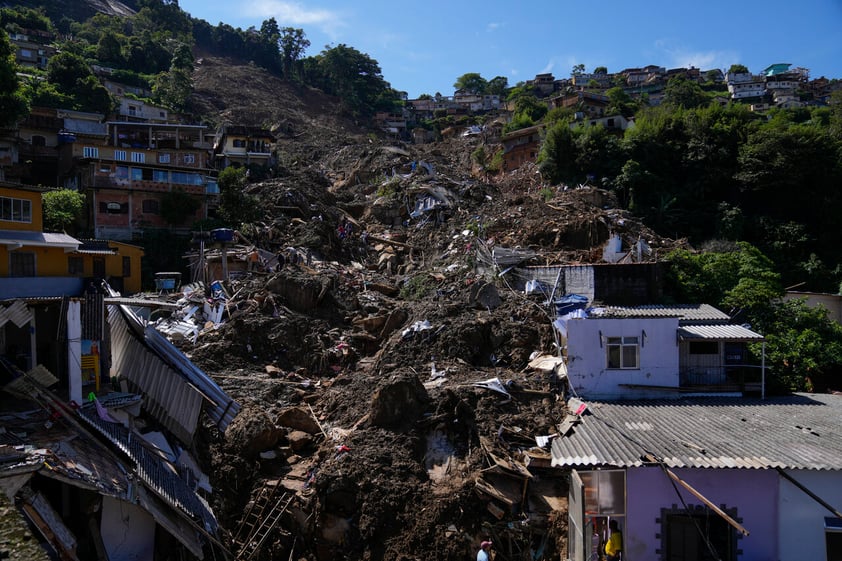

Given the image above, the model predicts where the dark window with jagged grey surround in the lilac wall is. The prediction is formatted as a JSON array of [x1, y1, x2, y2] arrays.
[[661, 506, 736, 561]]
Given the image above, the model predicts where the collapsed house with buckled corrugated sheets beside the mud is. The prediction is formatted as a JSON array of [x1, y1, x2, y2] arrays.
[[0, 287, 239, 561]]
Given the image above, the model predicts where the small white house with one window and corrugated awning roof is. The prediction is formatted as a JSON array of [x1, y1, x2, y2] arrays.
[[557, 304, 763, 400]]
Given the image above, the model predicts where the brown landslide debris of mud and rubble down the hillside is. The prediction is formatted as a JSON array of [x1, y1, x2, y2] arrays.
[[171, 57, 678, 560]]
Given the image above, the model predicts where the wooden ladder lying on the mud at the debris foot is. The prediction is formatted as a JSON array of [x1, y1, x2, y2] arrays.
[[234, 481, 295, 561]]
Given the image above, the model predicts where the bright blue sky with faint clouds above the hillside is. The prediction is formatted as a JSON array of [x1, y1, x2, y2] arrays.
[[179, 0, 842, 98]]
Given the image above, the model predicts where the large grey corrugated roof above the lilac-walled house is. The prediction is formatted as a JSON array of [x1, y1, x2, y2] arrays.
[[552, 394, 842, 470]]
